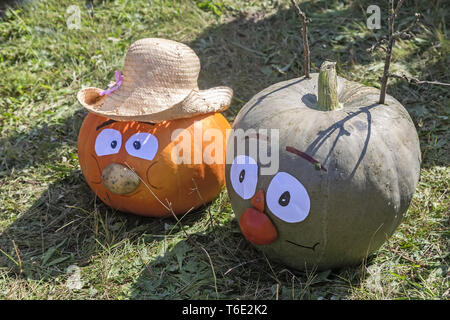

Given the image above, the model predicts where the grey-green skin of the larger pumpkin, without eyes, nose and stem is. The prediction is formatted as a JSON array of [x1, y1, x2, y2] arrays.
[[226, 73, 421, 270]]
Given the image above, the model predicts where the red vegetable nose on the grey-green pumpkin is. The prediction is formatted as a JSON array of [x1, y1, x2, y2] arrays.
[[239, 190, 278, 245]]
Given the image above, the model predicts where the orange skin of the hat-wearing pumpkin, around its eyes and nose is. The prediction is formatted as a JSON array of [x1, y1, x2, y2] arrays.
[[78, 113, 230, 217]]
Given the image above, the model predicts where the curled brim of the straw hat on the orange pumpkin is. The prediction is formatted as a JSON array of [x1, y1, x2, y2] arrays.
[[77, 86, 233, 122]]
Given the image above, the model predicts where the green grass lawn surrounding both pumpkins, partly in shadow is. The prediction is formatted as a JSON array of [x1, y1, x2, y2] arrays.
[[0, 0, 450, 299]]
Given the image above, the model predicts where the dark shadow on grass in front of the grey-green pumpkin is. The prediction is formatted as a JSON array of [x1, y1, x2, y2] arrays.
[[130, 221, 370, 300]]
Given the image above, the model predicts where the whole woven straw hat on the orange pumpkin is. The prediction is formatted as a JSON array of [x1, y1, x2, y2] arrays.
[[77, 38, 233, 122]]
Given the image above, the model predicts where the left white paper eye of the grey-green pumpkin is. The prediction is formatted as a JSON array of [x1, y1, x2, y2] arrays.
[[230, 155, 258, 200]]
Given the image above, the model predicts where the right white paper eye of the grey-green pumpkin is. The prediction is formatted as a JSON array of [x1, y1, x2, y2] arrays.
[[266, 172, 311, 223]]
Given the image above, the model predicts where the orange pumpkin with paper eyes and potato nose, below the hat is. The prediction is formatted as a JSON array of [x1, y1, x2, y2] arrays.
[[78, 113, 230, 217]]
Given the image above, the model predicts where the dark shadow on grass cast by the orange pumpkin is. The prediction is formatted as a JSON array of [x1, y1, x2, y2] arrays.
[[0, 170, 204, 282]]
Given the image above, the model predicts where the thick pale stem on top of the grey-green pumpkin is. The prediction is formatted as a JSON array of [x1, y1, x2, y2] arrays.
[[317, 61, 342, 111]]
